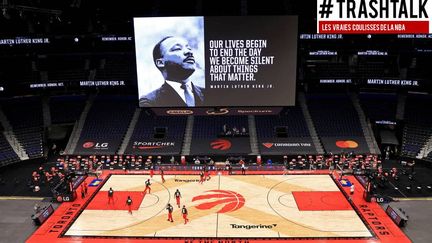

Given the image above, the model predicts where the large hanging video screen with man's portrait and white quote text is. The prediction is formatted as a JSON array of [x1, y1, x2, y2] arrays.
[[134, 16, 298, 107]]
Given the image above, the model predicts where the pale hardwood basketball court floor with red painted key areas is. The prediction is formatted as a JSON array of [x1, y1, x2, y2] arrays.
[[64, 174, 373, 239]]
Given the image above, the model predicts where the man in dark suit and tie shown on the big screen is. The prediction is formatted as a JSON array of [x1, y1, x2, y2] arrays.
[[139, 36, 204, 107]]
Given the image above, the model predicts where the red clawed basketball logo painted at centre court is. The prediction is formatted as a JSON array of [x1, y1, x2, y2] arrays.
[[192, 190, 245, 213]]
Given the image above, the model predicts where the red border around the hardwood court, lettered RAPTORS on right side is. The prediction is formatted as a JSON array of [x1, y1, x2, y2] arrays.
[[26, 170, 411, 243]]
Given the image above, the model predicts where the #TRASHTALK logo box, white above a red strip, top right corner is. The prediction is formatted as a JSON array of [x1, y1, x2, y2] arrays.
[[317, 0, 432, 34]]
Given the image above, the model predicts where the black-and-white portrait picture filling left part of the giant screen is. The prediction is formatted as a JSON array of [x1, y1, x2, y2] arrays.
[[134, 17, 205, 107]]
